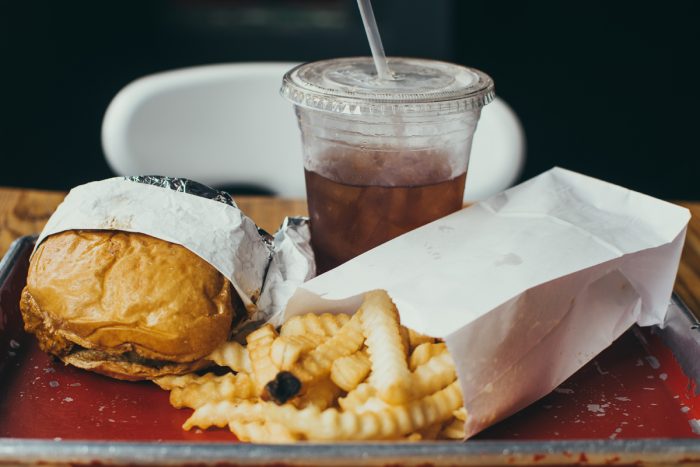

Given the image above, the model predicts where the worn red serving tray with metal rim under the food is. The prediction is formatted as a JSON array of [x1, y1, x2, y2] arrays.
[[0, 238, 700, 464]]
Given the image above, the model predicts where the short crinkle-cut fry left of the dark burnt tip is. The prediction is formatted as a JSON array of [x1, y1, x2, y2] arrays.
[[170, 373, 256, 409]]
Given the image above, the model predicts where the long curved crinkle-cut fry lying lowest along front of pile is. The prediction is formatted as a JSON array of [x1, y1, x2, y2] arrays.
[[211, 382, 462, 441]]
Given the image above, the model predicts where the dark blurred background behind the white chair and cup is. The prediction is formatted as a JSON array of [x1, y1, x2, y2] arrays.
[[0, 0, 700, 199]]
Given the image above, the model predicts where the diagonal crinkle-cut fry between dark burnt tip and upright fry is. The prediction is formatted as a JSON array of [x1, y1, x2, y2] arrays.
[[290, 308, 364, 393]]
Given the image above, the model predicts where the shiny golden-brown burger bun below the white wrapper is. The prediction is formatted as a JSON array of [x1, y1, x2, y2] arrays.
[[20, 231, 234, 379]]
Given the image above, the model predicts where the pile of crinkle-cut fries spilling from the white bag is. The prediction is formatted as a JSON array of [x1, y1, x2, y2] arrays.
[[155, 291, 467, 443]]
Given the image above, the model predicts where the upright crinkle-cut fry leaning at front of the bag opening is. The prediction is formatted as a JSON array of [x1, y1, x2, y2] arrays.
[[357, 290, 411, 404]]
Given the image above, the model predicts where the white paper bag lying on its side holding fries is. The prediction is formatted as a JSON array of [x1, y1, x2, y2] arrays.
[[275, 168, 690, 436]]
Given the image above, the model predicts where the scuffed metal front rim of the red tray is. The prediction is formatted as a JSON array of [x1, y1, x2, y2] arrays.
[[0, 438, 700, 465]]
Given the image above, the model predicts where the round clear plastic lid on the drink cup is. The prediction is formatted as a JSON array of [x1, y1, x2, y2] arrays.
[[280, 57, 494, 115]]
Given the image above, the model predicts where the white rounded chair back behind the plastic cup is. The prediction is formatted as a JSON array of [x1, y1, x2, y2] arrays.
[[102, 63, 525, 201]]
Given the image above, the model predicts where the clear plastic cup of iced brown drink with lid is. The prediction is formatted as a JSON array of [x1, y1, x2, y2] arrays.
[[281, 57, 494, 272]]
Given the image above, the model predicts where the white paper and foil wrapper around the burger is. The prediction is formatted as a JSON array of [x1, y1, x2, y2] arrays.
[[36, 176, 315, 330]]
